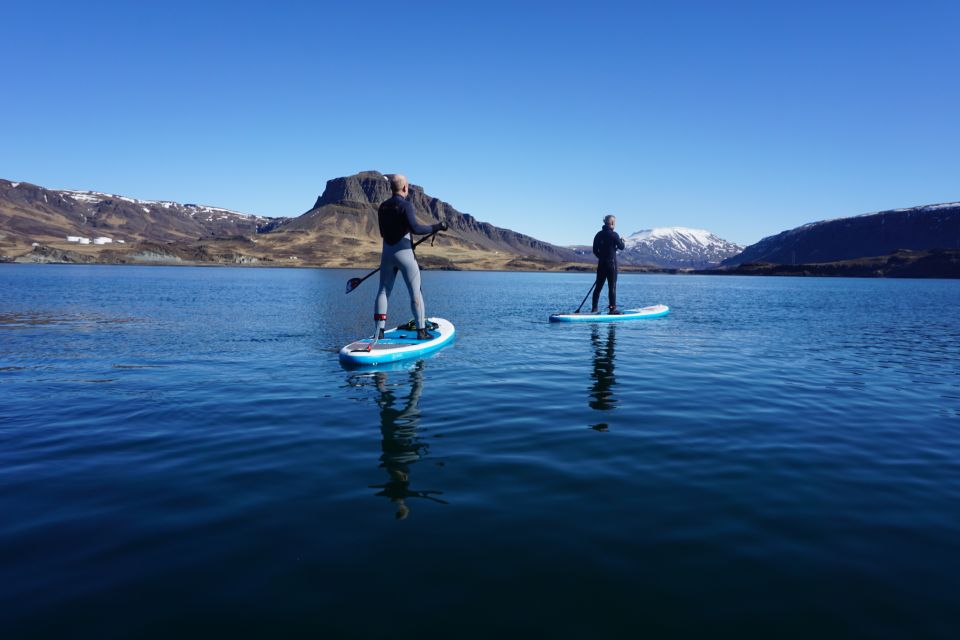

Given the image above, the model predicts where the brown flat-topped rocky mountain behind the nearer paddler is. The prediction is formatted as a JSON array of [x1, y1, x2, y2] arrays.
[[263, 171, 582, 269]]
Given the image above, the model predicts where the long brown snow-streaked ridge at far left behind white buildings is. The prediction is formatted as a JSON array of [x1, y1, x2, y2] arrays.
[[0, 180, 283, 248]]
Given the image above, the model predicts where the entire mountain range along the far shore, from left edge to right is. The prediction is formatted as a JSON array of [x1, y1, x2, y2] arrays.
[[0, 171, 960, 277]]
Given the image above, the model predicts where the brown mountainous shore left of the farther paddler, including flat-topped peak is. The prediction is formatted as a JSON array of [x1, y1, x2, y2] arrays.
[[0, 171, 586, 270]]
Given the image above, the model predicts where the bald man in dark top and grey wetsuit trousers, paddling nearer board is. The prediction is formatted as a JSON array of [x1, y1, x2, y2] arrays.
[[373, 174, 447, 340]]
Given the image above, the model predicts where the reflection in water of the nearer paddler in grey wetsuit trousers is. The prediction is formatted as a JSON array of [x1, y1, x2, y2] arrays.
[[371, 362, 447, 520]]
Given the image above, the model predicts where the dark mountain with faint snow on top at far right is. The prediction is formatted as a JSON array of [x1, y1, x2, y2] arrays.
[[723, 202, 960, 266]]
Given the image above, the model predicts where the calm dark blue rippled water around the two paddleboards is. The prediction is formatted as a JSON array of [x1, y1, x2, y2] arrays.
[[0, 265, 960, 638]]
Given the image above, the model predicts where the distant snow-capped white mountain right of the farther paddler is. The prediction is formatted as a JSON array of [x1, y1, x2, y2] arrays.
[[620, 227, 743, 269]]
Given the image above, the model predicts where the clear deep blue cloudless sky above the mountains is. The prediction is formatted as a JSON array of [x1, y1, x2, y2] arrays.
[[0, 1, 960, 244]]
